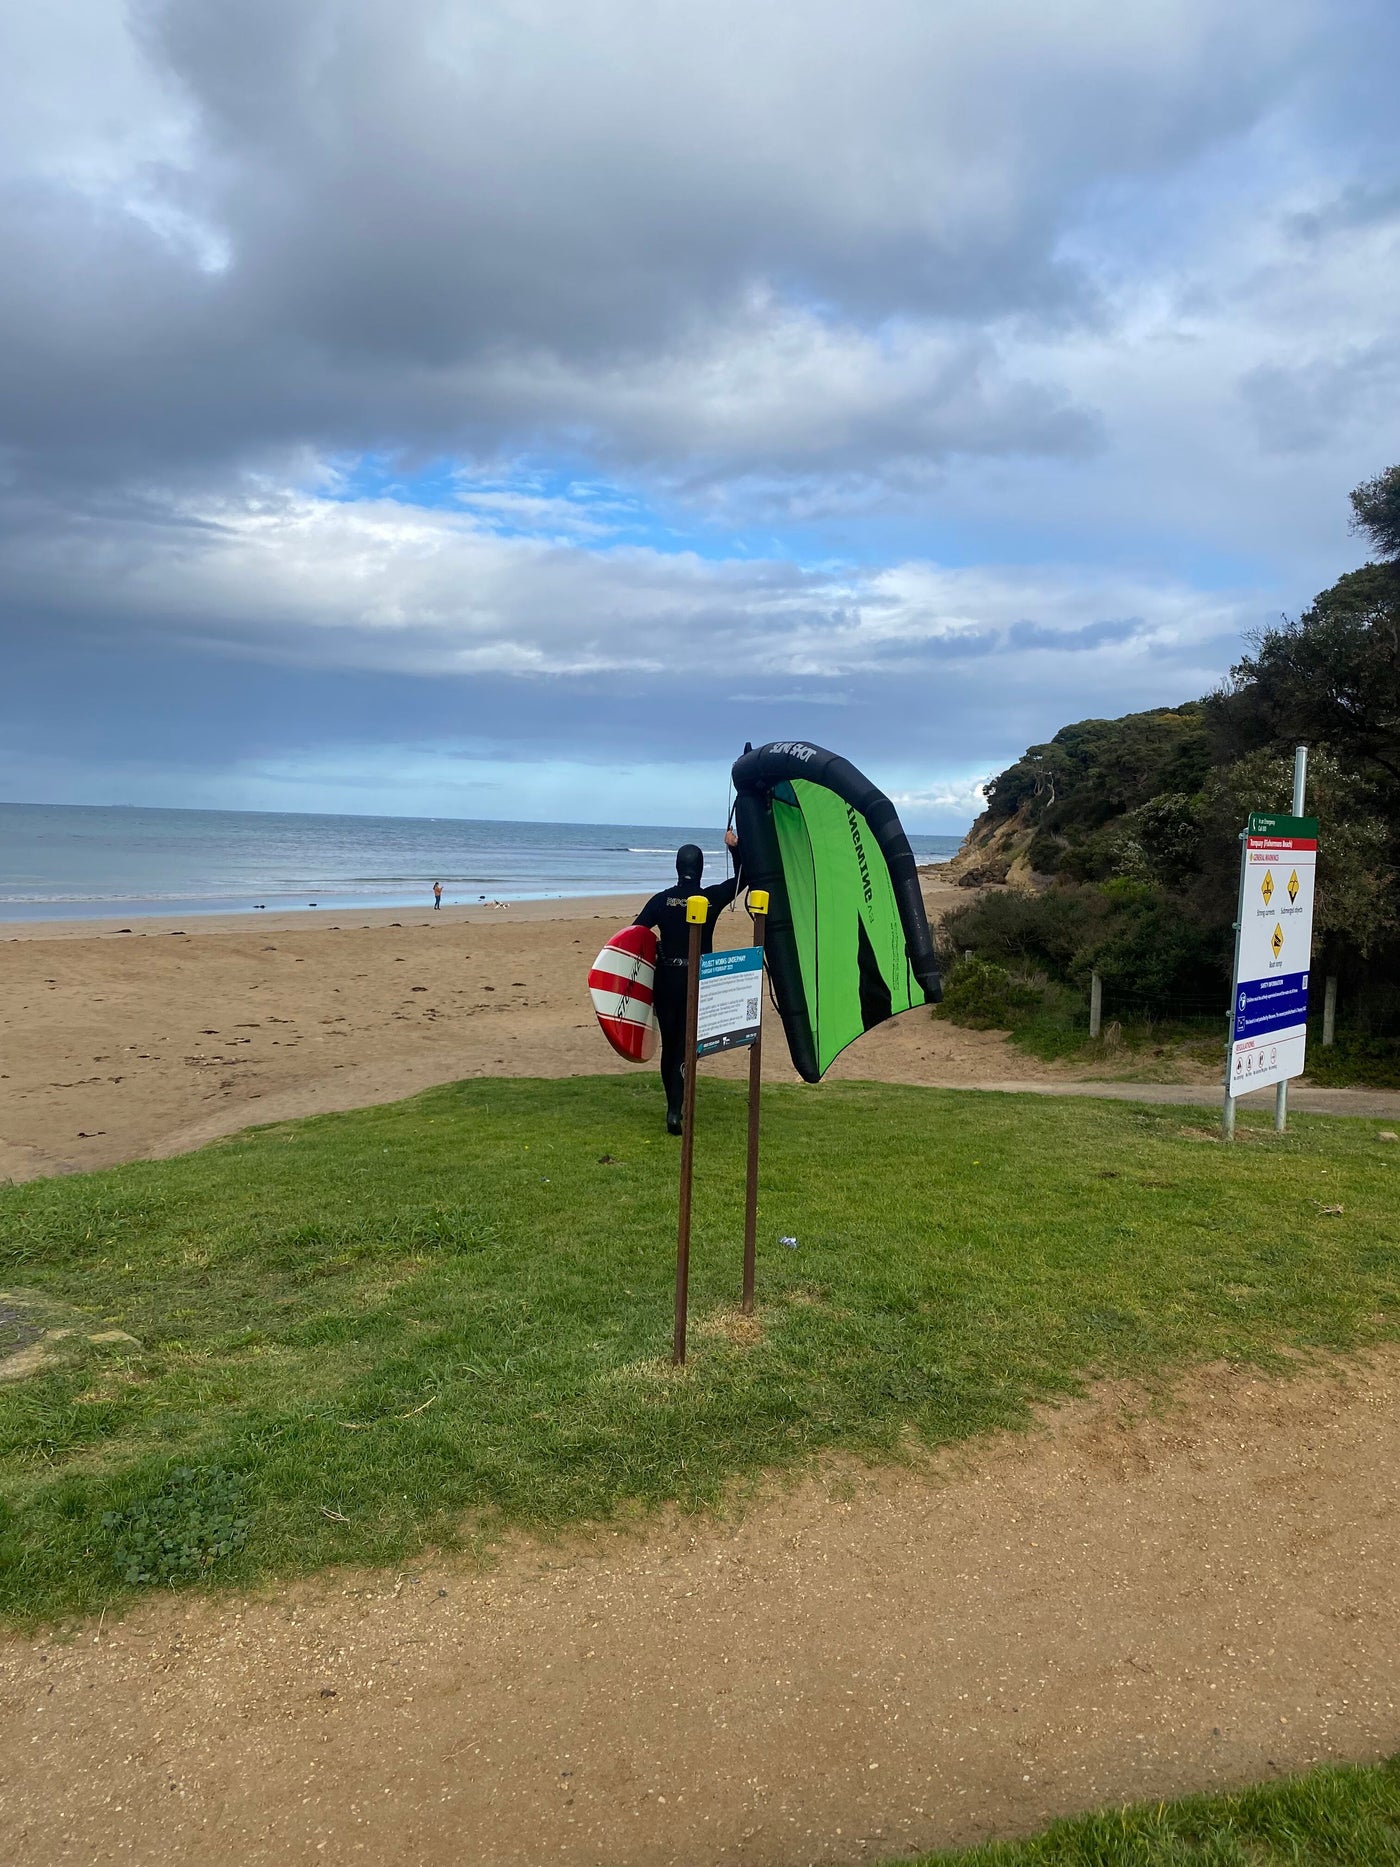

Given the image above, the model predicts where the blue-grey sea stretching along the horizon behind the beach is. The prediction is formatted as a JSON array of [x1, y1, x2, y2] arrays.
[[0, 805, 959, 920]]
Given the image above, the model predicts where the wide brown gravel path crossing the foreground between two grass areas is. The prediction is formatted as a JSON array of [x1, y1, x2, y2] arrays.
[[0, 1352, 1400, 1867]]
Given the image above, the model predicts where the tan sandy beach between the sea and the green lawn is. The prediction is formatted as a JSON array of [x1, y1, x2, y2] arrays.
[[0, 874, 1090, 1180]]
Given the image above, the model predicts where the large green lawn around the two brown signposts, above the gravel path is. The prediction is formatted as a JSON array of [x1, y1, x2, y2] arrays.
[[0, 1074, 1400, 1628]]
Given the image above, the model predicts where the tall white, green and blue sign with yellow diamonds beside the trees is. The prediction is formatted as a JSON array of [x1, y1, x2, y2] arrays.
[[1225, 814, 1318, 1096]]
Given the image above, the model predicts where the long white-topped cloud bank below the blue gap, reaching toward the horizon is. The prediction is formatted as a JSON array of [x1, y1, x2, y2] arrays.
[[0, 464, 1258, 795]]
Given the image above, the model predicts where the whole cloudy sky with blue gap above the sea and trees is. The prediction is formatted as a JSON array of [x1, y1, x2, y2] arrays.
[[0, 0, 1400, 831]]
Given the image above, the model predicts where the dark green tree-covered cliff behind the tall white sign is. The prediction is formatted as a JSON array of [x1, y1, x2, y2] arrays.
[[946, 467, 1400, 1034]]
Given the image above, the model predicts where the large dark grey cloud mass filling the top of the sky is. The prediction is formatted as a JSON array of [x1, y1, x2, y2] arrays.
[[0, 0, 1314, 492]]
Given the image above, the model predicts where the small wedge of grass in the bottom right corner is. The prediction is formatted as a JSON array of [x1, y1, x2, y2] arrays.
[[905, 1759, 1400, 1867]]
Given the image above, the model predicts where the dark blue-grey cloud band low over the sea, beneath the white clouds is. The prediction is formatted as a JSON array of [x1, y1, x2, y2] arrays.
[[0, 612, 1210, 787]]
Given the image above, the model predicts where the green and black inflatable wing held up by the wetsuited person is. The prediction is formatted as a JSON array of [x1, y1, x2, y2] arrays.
[[734, 739, 943, 1083]]
